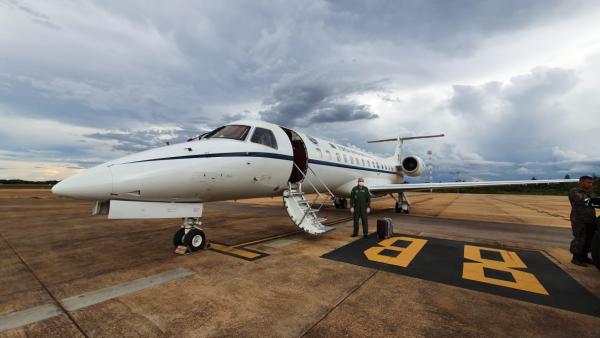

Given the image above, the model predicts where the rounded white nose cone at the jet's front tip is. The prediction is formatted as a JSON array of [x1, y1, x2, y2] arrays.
[[52, 167, 113, 200]]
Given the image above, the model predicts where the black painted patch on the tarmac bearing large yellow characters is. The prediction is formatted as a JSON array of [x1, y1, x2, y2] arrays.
[[321, 234, 600, 316]]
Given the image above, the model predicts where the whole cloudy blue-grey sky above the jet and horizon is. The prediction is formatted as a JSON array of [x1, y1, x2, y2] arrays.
[[0, 0, 600, 180]]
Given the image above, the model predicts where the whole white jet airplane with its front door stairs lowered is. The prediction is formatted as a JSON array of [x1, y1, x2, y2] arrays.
[[52, 121, 577, 251]]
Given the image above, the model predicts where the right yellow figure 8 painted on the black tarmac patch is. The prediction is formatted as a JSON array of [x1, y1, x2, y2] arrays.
[[463, 245, 549, 296]]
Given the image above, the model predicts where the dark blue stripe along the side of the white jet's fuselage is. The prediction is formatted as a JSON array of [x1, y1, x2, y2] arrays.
[[121, 151, 400, 175]]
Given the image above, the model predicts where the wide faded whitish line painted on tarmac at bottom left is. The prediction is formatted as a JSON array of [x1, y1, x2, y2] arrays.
[[0, 268, 194, 332]]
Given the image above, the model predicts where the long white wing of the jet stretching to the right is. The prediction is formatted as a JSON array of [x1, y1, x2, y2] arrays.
[[369, 179, 579, 193]]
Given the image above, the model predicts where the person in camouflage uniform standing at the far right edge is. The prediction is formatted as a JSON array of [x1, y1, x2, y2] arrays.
[[569, 176, 596, 266]]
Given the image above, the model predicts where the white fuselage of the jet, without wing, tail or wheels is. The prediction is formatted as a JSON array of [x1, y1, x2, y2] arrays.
[[53, 121, 403, 202]]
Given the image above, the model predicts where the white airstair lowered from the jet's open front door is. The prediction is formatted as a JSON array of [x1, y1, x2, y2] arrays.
[[283, 163, 335, 235]]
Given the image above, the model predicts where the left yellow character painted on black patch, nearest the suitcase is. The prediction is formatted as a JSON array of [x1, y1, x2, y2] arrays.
[[364, 237, 427, 268]]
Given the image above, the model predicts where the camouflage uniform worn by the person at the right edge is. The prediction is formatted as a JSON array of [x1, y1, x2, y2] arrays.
[[569, 187, 596, 257]]
